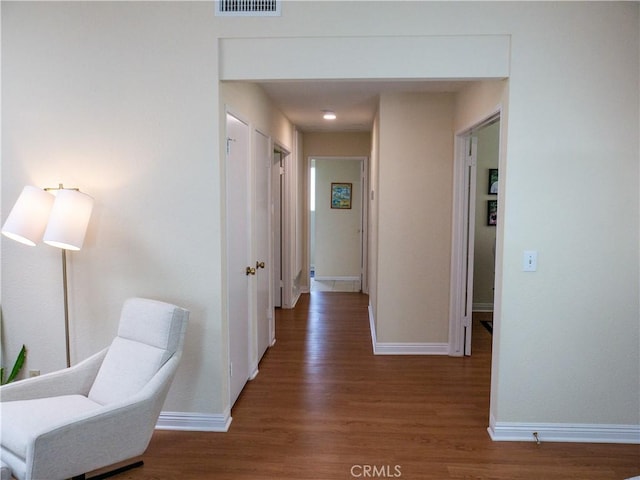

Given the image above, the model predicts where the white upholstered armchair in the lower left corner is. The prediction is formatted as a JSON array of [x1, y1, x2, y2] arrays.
[[0, 298, 189, 480]]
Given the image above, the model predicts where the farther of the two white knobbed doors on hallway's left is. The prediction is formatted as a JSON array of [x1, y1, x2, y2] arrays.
[[253, 131, 275, 362]]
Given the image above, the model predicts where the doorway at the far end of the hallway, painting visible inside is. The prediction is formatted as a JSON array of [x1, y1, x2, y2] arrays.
[[309, 157, 367, 292]]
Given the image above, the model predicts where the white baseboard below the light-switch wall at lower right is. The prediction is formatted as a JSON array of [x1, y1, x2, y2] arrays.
[[487, 419, 640, 444]]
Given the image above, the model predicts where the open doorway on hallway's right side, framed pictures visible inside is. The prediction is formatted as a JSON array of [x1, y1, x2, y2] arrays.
[[449, 112, 500, 356]]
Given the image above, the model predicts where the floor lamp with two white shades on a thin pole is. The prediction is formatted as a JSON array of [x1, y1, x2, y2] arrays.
[[2, 184, 93, 367]]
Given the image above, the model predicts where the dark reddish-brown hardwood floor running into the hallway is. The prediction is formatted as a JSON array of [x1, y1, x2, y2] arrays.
[[102, 293, 640, 480]]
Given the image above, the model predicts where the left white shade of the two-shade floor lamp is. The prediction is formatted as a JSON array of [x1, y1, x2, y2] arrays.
[[2, 185, 55, 247]]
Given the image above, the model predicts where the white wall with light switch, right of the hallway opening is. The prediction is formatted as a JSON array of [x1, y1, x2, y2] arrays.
[[496, 3, 640, 425]]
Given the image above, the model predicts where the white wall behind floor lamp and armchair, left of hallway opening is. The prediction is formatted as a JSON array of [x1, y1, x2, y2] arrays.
[[2, 2, 226, 413]]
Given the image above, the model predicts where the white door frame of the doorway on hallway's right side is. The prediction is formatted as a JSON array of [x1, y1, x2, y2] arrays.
[[449, 106, 503, 357]]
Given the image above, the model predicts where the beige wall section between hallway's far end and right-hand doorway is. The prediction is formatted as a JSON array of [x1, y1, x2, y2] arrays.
[[376, 93, 454, 343]]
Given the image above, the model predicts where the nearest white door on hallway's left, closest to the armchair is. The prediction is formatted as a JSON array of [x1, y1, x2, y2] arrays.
[[226, 113, 255, 406]]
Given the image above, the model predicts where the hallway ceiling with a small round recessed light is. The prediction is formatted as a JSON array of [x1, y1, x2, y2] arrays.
[[259, 80, 467, 132]]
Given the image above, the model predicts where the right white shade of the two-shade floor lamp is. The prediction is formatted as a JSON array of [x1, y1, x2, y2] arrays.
[[44, 188, 93, 250]]
